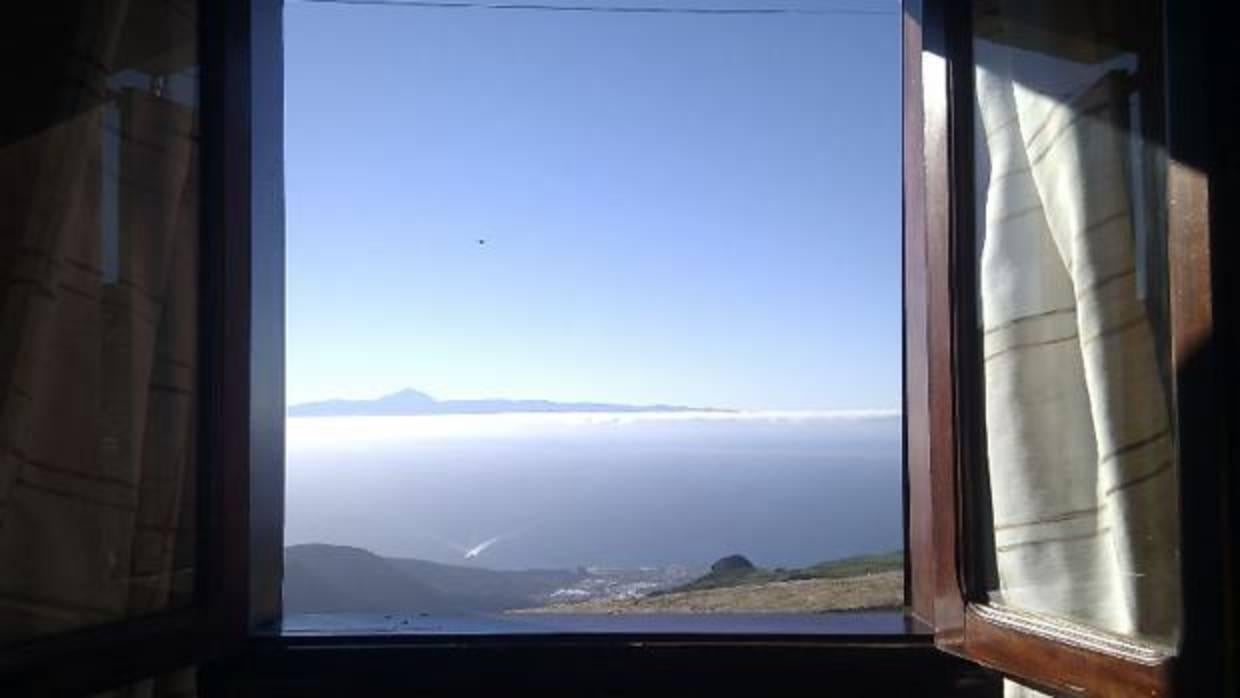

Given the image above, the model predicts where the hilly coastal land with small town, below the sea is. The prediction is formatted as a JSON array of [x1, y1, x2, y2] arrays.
[[284, 543, 904, 614]]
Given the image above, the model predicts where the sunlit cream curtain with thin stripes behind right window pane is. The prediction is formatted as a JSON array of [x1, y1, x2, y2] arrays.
[[976, 24, 1179, 694]]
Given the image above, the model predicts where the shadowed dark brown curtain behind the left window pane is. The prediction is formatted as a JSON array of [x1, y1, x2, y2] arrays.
[[0, 2, 198, 679]]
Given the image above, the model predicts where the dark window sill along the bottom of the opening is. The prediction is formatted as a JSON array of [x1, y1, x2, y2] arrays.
[[203, 610, 999, 698]]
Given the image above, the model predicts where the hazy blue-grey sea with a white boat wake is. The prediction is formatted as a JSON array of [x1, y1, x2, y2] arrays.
[[285, 412, 903, 569]]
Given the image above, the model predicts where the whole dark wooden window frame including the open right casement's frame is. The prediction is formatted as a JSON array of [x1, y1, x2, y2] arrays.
[[0, 0, 1240, 696]]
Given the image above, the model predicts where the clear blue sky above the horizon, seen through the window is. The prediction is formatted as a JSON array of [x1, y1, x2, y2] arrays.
[[285, 0, 900, 409]]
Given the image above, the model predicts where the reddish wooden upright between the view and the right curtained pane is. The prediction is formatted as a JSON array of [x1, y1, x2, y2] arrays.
[[905, 0, 963, 651]]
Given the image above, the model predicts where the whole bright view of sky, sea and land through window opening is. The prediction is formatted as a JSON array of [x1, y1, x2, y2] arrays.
[[284, 2, 904, 631]]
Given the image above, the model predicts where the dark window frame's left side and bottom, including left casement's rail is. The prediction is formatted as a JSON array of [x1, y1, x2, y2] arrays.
[[7, 0, 997, 696]]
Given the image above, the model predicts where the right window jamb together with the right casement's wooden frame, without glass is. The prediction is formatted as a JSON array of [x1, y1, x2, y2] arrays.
[[904, 0, 1238, 696]]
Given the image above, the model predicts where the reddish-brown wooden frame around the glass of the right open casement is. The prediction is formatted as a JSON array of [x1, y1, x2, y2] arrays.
[[923, 0, 1238, 696]]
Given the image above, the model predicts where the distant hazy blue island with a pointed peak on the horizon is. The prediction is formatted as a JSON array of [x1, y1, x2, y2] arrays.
[[288, 388, 733, 417]]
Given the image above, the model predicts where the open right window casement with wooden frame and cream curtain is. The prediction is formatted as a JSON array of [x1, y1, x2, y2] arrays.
[[904, 0, 1235, 696]]
